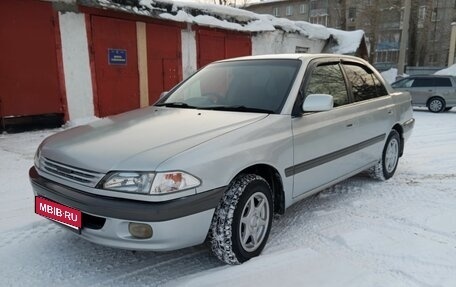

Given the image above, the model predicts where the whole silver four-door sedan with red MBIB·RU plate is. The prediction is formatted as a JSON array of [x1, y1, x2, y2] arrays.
[[30, 54, 414, 264]]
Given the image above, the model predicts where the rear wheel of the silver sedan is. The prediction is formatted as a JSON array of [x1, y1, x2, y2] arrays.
[[368, 130, 401, 181]]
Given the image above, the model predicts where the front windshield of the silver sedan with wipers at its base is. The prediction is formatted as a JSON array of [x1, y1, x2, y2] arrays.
[[156, 59, 301, 113]]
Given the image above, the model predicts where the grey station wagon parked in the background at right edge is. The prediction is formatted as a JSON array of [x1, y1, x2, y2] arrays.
[[391, 75, 456, 113]]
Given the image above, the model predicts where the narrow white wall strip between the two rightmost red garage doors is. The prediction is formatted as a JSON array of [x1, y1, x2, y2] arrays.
[[181, 26, 197, 79]]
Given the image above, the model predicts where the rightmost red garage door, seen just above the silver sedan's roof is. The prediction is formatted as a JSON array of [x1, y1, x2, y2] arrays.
[[197, 29, 252, 68]]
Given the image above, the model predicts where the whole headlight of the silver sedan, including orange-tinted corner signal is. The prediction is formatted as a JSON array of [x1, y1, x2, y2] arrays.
[[101, 171, 201, 195]]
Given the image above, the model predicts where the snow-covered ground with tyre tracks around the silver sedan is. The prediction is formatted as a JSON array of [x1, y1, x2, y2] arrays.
[[0, 109, 456, 287]]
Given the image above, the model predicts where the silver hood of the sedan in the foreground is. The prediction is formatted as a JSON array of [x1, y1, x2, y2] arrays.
[[41, 107, 267, 173]]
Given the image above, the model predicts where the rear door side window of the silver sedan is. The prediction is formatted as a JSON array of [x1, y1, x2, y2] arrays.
[[344, 64, 386, 102]]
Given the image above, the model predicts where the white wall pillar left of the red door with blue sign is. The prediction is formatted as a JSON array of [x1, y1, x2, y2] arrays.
[[59, 12, 95, 120]]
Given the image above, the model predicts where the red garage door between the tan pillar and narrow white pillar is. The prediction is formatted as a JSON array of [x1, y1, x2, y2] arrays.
[[147, 23, 182, 105]]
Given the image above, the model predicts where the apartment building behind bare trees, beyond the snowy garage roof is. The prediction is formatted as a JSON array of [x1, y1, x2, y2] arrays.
[[246, 0, 456, 70]]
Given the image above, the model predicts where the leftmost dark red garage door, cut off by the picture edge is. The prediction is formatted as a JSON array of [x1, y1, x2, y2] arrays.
[[0, 0, 63, 118]]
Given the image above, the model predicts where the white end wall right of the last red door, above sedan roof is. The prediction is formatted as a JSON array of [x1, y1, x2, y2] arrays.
[[252, 31, 325, 55]]
